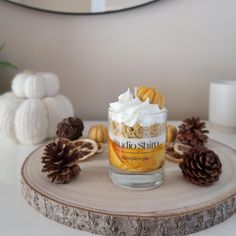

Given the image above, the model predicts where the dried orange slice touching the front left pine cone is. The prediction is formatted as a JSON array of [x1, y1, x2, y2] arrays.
[[72, 138, 98, 161]]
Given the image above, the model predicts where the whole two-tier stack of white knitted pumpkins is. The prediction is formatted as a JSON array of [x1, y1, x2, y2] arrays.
[[0, 71, 74, 144]]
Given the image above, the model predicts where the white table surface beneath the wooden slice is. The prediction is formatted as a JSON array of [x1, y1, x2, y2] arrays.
[[0, 122, 236, 236]]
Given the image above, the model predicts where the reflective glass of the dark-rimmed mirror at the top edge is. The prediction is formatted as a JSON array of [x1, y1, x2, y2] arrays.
[[8, 0, 159, 14]]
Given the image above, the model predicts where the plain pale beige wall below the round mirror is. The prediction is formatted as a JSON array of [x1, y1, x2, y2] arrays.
[[0, 0, 236, 119]]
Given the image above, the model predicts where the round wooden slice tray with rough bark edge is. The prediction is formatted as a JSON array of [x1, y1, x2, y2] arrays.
[[22, 141, 236, 236]]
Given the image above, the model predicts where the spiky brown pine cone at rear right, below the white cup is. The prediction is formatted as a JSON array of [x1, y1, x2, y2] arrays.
[[178, 117, 209, 147]]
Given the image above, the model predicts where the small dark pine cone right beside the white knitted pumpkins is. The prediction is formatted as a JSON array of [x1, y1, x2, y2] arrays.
[[56, 117, 84, 140]]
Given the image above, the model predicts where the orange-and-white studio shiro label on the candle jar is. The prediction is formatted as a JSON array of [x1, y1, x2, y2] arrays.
[[109, 134, 165, 172]]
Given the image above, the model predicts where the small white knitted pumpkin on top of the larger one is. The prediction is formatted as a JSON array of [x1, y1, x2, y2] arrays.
[[12, 70, 60, 98]]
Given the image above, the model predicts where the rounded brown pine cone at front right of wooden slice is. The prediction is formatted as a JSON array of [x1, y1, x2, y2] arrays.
[[179, 147, 222, 186]]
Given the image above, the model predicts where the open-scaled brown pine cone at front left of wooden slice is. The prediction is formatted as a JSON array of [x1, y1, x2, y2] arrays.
[[41, 138, 80, 184]]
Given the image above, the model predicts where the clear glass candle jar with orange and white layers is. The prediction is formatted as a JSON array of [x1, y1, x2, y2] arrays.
[[108, 110, 167, 190]]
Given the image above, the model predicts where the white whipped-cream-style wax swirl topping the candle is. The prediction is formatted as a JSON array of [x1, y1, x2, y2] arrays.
[[109, 89, 166, 127]]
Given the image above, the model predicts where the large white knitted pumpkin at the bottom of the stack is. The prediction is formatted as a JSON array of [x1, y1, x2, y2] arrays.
[[0, 93, 74, 144]]
